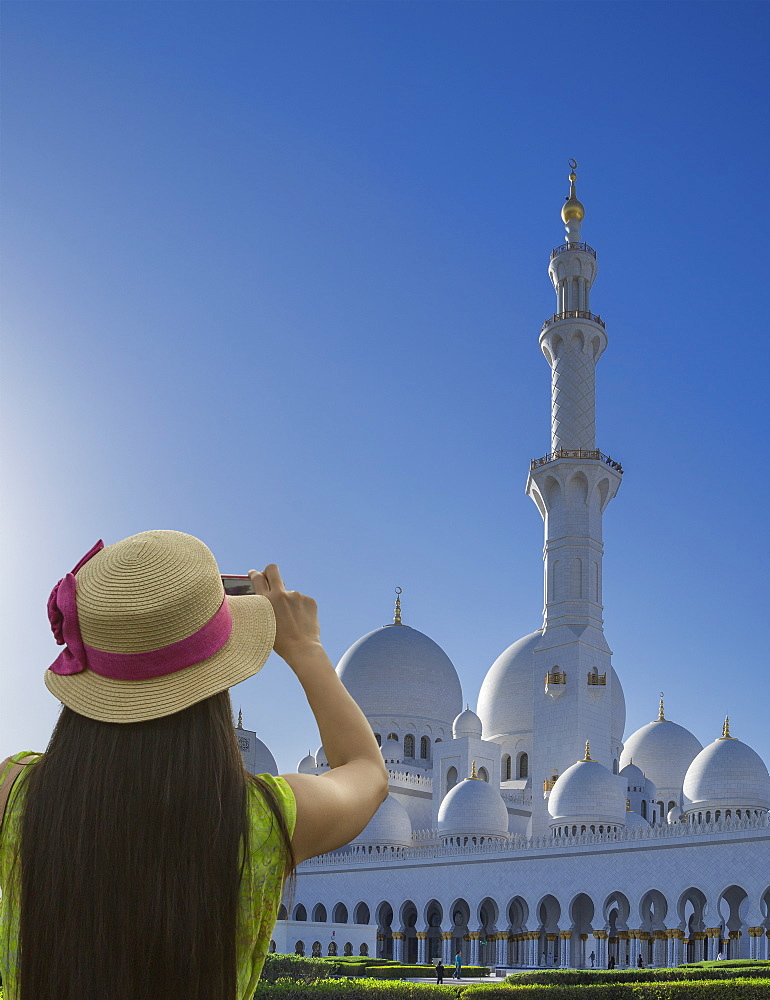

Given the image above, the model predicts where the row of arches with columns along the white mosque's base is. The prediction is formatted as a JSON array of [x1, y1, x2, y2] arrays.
[[292, 884, 770, 968]]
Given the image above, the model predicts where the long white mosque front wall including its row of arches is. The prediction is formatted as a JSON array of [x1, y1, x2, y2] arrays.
[[294, 825, 770, 967]]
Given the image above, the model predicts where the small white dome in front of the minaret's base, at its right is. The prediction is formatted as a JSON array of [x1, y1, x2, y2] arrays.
[[548, 760, 626, 826]]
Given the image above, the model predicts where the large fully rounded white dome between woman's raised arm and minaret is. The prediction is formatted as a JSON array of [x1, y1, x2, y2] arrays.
[[337, 625, 463, 729]]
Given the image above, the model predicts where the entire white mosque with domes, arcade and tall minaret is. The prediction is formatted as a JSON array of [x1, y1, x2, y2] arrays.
[[238, 168, 770, 968]]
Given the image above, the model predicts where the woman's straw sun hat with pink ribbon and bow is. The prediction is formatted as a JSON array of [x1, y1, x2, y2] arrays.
[[45, 531, 275, 722]]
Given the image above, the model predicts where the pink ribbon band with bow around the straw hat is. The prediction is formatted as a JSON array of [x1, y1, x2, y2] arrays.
[[48, 541, 233, 681]]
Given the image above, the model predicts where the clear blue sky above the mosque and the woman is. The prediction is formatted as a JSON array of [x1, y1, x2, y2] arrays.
[[0, 0, 770, 770]]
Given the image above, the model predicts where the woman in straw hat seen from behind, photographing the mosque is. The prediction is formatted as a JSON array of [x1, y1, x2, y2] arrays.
[[0, 531, 388, 1000]]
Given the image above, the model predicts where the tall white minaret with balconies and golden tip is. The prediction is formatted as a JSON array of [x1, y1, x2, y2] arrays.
[[527, 160, 623, 833]]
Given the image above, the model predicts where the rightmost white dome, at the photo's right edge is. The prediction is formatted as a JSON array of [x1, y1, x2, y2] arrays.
[[682, 736, 770, 813]]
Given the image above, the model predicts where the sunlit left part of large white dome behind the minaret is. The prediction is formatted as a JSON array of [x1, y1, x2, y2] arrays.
[[477, 629, 543, 739]]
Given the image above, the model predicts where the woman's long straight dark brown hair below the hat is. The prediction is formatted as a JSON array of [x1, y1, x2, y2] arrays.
[[19, 691, 294, 1000]]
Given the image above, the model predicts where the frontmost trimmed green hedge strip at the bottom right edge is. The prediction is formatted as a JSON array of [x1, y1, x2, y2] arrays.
[[461, 979, 770, 1000]]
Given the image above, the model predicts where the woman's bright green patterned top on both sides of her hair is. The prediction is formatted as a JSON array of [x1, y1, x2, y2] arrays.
[[0, 753, 297, 1000]]
